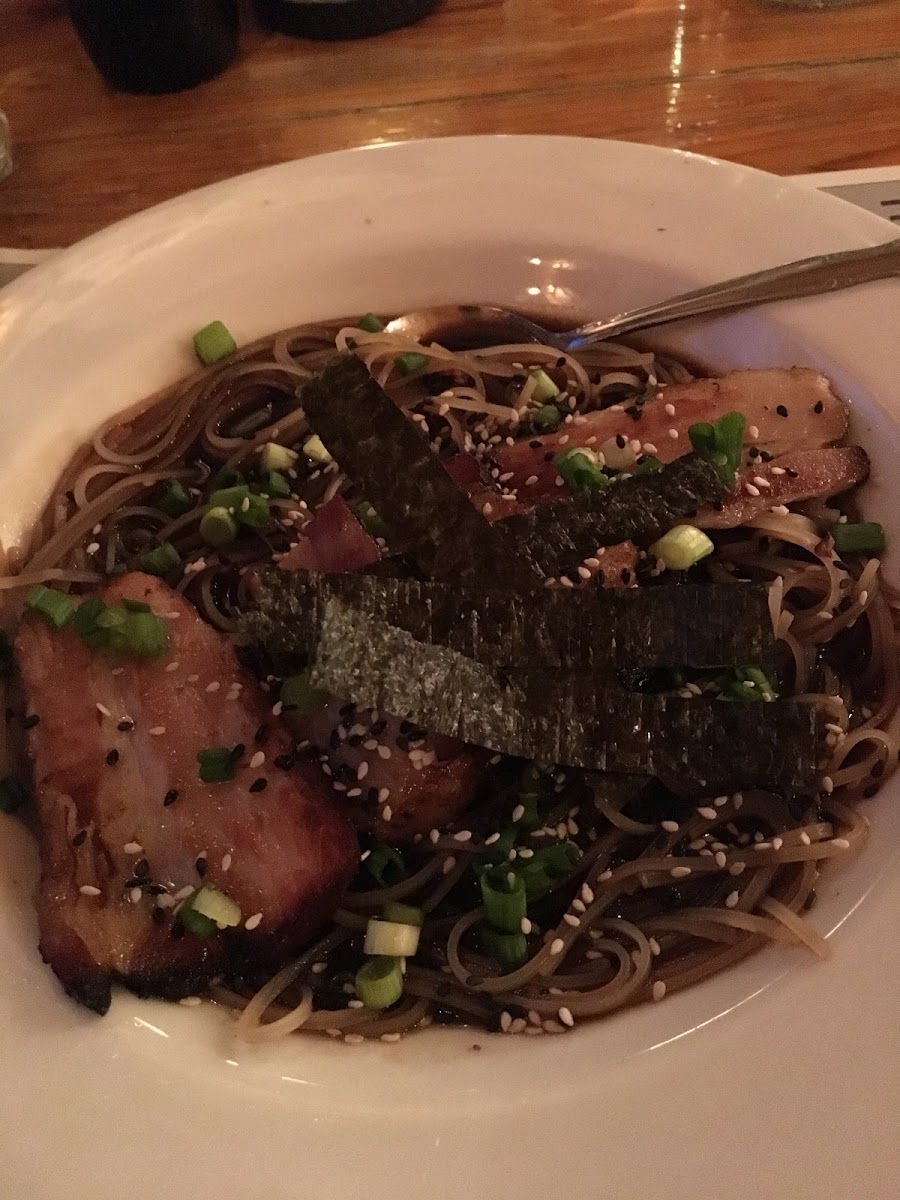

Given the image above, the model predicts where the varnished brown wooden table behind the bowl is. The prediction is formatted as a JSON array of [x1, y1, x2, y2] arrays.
[[0, 0, 900, 247]]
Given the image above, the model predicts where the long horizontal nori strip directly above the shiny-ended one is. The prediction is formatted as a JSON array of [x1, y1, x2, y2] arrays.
[[242, 568, 775, 673]]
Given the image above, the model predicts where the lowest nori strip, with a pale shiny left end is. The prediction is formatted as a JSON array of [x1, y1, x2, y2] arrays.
[[311, 596, 818, 794]]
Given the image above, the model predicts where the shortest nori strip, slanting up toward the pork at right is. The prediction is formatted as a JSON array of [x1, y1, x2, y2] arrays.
[[499, 454, 726, 576]]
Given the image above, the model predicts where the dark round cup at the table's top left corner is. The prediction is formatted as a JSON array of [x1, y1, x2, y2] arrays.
[[68, 0, 239, 94]]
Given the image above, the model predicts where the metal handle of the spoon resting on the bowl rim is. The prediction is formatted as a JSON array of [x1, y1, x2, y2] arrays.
[[568, 239, 900, 349]]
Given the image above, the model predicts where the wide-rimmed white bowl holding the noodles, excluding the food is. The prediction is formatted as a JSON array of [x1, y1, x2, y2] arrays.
[[0, 137, 900, 1200]]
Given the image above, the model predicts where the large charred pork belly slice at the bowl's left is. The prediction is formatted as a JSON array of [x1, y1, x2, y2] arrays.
[[16, 574, 358, 1013]]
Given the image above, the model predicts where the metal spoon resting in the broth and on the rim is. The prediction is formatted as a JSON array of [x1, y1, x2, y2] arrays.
[[388, 239, 900, 350]]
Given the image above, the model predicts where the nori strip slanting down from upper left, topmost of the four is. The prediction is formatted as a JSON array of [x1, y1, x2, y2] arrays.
[[299, 354, 540, 588]]
